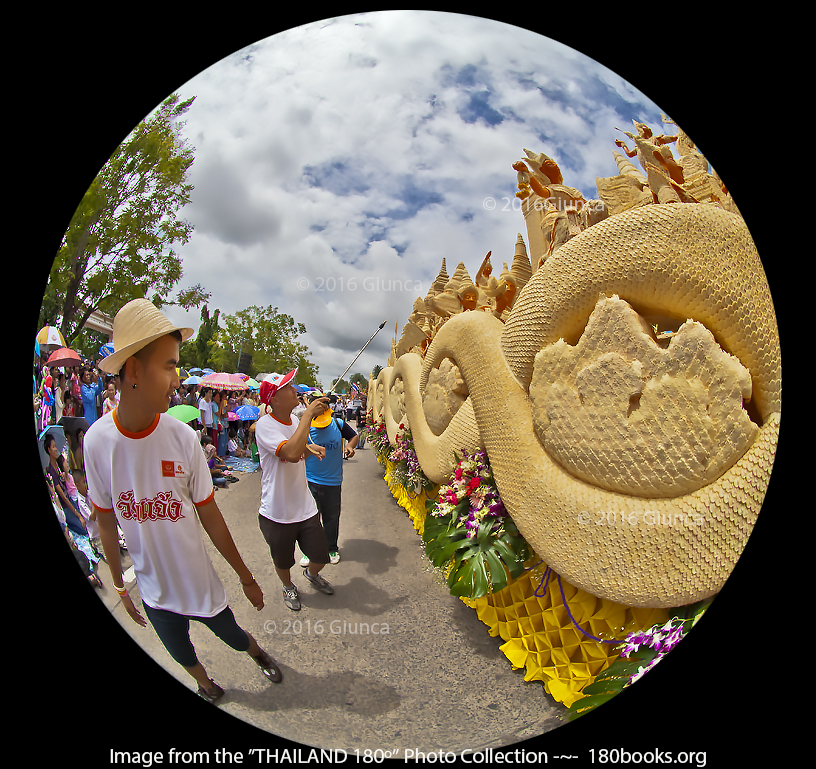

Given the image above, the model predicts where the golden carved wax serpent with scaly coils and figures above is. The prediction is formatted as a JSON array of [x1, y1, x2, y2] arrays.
[[369, 118, 781, 607]]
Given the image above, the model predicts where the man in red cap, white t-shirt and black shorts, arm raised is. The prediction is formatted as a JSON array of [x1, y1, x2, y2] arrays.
[[255, 368, 334, 611]]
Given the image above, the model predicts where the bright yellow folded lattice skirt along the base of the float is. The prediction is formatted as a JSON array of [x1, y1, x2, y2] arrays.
[[384, 460, 668, 707]]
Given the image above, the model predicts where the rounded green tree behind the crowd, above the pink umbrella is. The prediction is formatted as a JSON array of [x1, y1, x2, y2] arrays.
[[210, 305, 318, 386]]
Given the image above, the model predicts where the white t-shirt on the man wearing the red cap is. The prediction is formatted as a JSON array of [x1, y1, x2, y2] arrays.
[[256, 414, 317, 523]]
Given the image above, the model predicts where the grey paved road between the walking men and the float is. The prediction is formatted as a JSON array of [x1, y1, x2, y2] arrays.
[[95, 438, 565, 755]]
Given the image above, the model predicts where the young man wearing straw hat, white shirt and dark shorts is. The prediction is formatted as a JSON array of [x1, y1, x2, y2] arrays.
[[85, 299, 282, 702]]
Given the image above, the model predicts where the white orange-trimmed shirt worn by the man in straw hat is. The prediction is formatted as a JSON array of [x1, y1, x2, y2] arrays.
[[84, 410, 227, 617]]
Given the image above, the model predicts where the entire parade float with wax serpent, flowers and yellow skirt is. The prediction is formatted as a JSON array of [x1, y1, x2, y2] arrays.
[[368, 118, 781, 712]]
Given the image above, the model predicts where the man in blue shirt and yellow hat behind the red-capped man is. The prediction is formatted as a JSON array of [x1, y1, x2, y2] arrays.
[[300, 392, 359, 566]]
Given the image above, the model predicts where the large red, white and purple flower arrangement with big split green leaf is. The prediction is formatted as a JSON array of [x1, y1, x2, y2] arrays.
[[422, 450, 530, 598]]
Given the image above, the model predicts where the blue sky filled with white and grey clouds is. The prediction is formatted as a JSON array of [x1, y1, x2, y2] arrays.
[[110, 11, 676, 385]]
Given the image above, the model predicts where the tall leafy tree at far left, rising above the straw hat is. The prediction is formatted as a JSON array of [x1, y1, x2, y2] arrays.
[[40, 94, 209, 345]]
